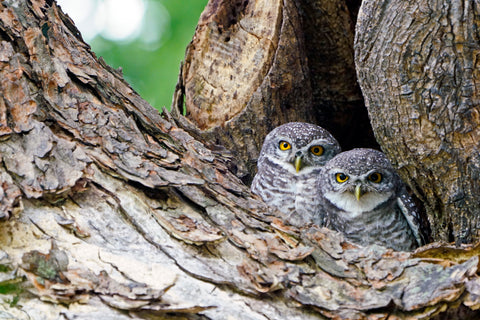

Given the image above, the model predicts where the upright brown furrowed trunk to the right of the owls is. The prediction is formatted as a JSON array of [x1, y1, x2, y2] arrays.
[[356, 0, 480, 243]]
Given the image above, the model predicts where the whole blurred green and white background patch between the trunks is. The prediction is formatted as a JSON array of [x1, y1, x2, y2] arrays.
[[58, 0, 208, 110]]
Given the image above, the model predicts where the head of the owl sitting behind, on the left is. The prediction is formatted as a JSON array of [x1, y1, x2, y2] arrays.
[[259, 122, 340, 174]]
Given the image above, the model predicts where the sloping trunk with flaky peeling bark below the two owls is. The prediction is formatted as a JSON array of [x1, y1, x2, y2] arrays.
[[0, 0, 480, 319]]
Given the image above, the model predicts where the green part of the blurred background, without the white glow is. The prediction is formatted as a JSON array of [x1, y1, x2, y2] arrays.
[[90, 0, 208, 110]]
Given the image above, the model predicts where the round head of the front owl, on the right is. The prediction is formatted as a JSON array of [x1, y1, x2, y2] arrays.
[[320, 148, 403, 214]]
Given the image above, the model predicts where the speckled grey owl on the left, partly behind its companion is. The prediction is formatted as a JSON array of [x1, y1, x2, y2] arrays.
[[251, 122, 340, 227]]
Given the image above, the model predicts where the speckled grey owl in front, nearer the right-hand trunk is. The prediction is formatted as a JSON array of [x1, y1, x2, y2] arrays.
[[318, 149, 423, 251]]
